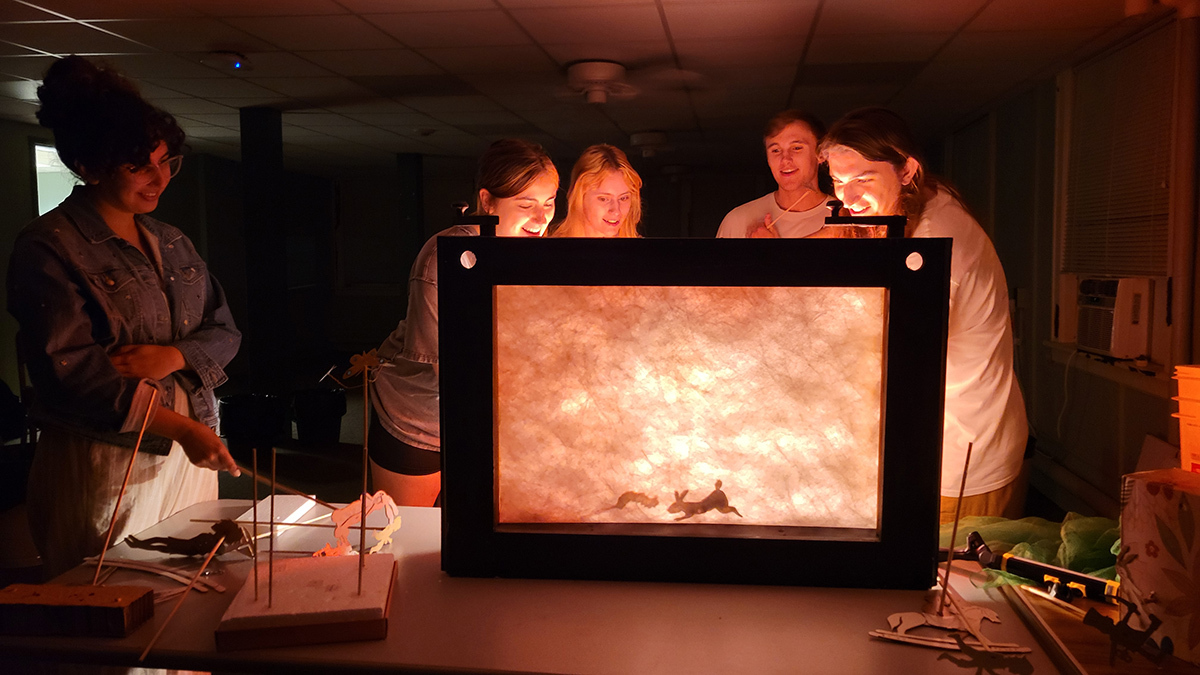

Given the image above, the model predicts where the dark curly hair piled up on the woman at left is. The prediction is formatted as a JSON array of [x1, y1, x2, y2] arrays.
[[37, 56, 185, 177]]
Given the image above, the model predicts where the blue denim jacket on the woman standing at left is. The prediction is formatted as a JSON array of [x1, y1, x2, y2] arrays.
[[8, 187, 241, 454]]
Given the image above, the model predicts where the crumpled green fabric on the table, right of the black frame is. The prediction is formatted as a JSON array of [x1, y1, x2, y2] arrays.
[[940, 513, 1121, 585]]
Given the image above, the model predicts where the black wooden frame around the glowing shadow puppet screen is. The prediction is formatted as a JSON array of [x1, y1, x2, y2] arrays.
[[438, 237, 950, 589]]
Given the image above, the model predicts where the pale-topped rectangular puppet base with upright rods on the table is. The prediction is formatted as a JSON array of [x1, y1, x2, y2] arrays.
[[216, 554, 396, 650]]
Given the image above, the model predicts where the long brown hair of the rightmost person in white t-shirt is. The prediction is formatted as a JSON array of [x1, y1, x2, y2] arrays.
[[817, 103, 961, 235]]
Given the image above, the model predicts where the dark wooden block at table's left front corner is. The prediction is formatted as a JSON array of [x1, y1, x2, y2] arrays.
[[0, 584, 154, 638]]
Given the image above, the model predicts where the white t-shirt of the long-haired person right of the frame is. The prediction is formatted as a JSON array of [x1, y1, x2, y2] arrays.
[[913, 191, 1028, 497]]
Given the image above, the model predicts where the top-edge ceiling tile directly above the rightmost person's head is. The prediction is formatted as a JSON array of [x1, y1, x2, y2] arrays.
[[817, 0, 988, 36]]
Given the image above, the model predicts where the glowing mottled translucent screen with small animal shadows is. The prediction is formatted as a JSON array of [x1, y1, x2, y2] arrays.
[[496, 281, 886, 528]]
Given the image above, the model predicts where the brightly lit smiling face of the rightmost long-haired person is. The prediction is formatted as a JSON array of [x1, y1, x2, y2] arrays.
[[826, 145, 917, 216]]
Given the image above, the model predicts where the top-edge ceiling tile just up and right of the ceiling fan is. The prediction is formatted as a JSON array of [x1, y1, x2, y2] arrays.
[[662, 0, 829, 40]]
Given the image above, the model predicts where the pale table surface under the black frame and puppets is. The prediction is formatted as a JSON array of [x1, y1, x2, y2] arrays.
[[0, 500, 1057, 675]]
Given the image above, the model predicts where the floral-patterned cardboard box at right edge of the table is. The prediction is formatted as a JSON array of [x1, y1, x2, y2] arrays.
[[1117, 468, 1200, 664]]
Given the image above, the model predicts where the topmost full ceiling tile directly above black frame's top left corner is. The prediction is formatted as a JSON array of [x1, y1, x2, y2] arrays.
[[364, 10, 529, 48]]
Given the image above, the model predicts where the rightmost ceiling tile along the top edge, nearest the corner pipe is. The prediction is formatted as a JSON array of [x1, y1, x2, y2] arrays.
[[967, 0, 1124, 31]]
